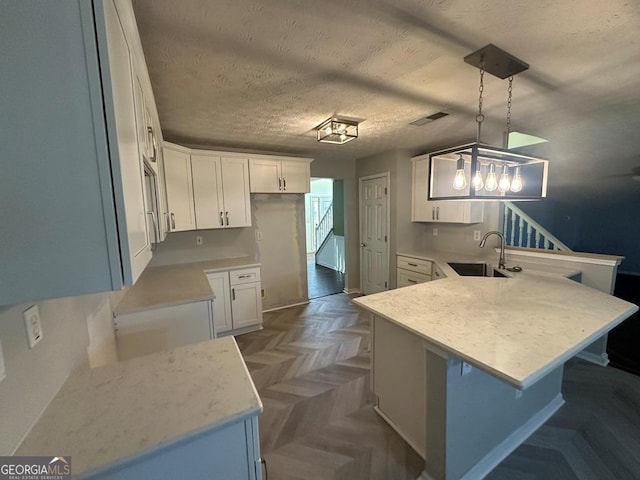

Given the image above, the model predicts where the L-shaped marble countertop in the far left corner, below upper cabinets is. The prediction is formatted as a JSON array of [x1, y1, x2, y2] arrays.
[[113, 257, 260, 315]]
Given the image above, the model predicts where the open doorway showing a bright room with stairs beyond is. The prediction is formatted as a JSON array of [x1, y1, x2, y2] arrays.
[[305, 178, 345, 298]]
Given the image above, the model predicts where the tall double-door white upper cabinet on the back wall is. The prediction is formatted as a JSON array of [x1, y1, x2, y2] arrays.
[[191, 154, 251, 230]]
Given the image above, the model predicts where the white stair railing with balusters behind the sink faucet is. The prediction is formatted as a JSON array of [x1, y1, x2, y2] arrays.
[[502, 202, 571, 252]]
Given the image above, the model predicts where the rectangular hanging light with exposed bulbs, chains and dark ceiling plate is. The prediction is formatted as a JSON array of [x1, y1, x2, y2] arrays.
[[428, 45, 549, 200]]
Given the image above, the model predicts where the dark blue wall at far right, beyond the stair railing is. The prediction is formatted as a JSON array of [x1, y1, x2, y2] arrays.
[[517, 182, 640, 274]]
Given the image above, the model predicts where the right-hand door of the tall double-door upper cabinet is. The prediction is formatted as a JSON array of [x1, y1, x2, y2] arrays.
[[220, 157, 251, 227]]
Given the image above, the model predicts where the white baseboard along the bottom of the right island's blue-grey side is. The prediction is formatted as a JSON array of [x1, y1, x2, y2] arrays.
[[456, 393, 564, 480]]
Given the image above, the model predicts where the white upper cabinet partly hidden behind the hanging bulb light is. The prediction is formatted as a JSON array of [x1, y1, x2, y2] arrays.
[[411, 155, 484, 223]]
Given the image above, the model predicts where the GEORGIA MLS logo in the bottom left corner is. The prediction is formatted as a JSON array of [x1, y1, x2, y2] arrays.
[[0, 456, 71, 480]]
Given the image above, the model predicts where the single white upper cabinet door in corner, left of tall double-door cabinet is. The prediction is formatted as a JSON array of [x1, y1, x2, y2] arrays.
[[164, 147, 196, 232]]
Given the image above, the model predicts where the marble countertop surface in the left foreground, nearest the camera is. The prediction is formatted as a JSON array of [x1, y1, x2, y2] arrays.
[[15, 337, 262, 474]]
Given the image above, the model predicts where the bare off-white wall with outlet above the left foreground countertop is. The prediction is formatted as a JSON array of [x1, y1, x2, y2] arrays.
[[0, 292, 123, 455]]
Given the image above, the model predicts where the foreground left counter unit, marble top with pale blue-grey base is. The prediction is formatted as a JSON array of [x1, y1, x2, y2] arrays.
[[15, 337, 262, 480]]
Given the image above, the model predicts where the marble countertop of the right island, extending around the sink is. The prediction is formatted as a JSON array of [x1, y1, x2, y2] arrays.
[[353, 252, 638, 388]]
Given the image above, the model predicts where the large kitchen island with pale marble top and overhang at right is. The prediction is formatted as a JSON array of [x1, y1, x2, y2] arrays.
[[353, 272, 638, 480]]
